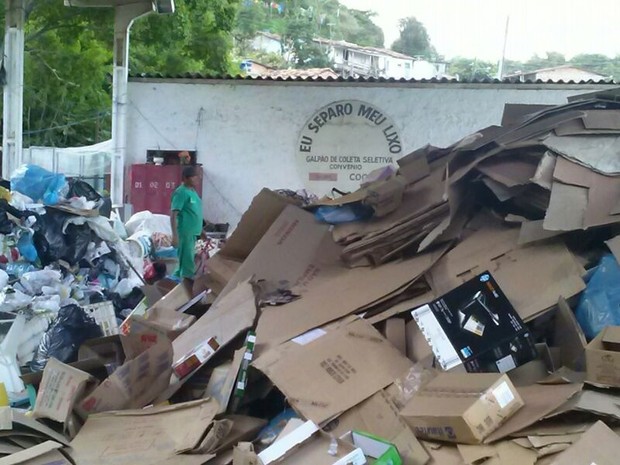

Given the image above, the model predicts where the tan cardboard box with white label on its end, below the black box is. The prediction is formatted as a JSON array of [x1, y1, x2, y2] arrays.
[[400, 373, 523, 444]]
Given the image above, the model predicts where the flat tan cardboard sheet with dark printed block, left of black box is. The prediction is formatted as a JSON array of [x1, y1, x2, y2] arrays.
[[254, 320, 412, 424]]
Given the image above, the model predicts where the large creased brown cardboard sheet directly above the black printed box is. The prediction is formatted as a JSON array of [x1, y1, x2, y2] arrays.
[[429, 218, 585, 322]]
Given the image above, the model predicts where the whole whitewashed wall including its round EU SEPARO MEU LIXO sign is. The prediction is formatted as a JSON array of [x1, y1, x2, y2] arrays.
[[126, 77, 608, 226]]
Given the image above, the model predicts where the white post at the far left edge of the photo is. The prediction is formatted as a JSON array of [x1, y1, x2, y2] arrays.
[[2, 0, 25, 179]]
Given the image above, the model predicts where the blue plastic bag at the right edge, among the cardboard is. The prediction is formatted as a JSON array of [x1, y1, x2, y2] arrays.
[[575, 255, 620, 340]]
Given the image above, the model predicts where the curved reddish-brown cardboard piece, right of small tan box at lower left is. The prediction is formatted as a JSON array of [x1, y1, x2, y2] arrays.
[[78, 339, 172, 415]]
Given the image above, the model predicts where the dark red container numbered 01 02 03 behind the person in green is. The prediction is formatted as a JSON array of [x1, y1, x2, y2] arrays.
[[125, 164, 202, 215]]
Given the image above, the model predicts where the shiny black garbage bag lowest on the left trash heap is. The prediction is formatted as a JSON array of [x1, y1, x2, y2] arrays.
[[30, 305, 103, 371]]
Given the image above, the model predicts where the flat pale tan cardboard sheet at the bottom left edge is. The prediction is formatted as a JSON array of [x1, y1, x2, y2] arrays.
[[71, 399, 219, 465]]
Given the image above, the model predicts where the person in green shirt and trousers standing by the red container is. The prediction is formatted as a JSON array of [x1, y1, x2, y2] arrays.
[[170, 166, 202, 281]]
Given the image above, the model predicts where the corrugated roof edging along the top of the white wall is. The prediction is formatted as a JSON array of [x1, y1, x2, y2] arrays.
[[130, 68, 615, 86]]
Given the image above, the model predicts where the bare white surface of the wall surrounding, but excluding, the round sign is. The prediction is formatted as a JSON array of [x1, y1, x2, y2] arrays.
[[127, 78, 607, 226]]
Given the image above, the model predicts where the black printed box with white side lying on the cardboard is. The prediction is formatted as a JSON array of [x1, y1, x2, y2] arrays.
[[411, 272, 537, 373]]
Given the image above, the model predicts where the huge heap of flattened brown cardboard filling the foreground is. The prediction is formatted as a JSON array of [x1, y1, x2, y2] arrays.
[[8, 92, 620, 465]]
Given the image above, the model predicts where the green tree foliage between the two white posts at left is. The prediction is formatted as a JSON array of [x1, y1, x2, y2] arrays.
[[5, 0, 113, 146]]
